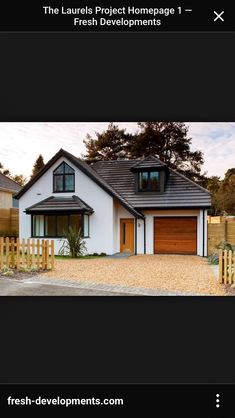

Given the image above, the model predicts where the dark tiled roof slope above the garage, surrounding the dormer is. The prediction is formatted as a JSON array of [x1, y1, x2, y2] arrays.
[[92, 160, 211, 210]]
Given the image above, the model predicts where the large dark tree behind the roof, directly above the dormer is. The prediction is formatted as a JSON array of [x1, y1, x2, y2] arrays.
[[129, 122, 204, 179]]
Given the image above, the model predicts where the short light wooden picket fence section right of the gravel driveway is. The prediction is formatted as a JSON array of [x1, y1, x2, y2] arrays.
[[219, 250, 235, 284]]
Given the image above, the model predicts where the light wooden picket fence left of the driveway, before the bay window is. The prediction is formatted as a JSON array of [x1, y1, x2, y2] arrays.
[[0, 237, 55, 270]]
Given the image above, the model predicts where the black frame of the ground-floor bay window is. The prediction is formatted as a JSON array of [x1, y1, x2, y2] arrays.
[[31, 212, 90, 239]]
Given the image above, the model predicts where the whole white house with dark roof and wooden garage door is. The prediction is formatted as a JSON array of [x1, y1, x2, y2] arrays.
[[16, 149, 211, 256]]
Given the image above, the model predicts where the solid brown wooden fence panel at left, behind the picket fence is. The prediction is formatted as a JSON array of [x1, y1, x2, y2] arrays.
[[0, 208, 19, 237]]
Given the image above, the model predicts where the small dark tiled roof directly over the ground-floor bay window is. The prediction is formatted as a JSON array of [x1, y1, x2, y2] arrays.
[[26, 196, 94, 213]]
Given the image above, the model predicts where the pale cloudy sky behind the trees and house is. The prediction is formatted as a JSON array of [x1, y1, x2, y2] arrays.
[[0, 122, 235, 178]]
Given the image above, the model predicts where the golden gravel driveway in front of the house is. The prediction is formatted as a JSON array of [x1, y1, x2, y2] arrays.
[[43, 255, 225, 296]]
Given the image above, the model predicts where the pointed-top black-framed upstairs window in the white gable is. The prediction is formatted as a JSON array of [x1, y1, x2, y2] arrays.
[[53, 163, 75, 193]]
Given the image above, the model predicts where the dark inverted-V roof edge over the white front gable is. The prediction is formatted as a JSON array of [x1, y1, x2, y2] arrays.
[[15, 148, 143, 218]]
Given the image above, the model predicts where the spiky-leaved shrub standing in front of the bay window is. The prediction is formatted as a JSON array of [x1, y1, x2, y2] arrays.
[[59, 226, 87, 258]]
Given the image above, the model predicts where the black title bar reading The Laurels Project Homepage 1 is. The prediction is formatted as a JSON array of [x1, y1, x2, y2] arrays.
[[0, 0, 235, 32]]
